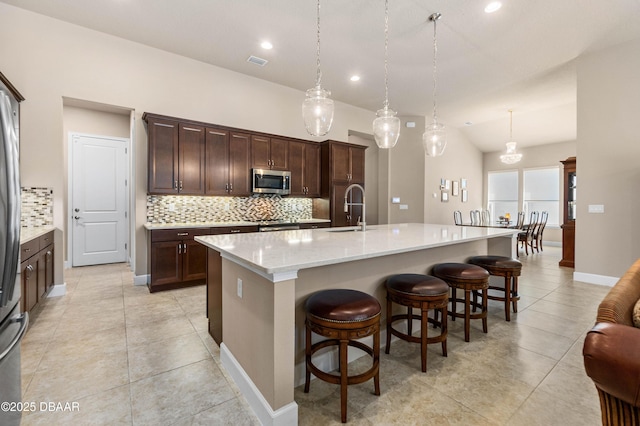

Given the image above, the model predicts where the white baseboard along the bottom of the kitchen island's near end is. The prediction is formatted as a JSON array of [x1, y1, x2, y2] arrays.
[[220, 343, 298, 426]]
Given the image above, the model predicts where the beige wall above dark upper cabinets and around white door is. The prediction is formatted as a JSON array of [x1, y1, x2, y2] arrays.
[[0, 3, 375, 275]]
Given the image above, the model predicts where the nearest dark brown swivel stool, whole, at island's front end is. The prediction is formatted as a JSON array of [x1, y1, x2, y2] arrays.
[[304, 289, 382, 423]]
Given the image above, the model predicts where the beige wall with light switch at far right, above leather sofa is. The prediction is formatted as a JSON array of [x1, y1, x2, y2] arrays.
[[576, 40, 640, 277]]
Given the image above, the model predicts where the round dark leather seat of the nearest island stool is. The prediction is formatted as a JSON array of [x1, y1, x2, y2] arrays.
[[305, 289, 381, 322]]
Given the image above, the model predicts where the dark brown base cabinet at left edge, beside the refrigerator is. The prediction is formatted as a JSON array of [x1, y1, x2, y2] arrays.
[[20, 231, 54, 312]]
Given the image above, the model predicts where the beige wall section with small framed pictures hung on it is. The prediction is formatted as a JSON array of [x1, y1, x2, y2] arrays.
[[422, 127, 483, 225]]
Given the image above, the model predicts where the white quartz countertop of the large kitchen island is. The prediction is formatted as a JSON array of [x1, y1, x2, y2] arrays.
[[195, 223, 519, 277]]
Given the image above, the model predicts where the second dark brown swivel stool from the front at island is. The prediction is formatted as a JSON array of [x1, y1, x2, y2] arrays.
[[385, 274, 449, 372]]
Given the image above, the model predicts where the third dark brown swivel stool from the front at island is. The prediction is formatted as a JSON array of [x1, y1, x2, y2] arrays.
[[432, 263, 489, 342]]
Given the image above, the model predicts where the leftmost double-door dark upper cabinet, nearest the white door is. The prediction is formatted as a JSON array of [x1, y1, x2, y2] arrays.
[[142, 113, 205, 195]]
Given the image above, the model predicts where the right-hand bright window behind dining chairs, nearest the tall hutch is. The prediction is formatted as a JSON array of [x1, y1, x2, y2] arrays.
[[522, 167, 560, 226]]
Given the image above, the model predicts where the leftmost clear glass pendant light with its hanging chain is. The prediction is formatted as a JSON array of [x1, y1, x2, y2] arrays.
[[302, 0, 333, 136]]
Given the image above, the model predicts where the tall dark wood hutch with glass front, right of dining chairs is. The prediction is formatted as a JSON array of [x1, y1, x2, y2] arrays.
[[560, 157, 577, 268]]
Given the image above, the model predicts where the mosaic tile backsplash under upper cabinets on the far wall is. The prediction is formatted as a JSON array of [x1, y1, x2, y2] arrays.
[[147, 195, 313, 224]]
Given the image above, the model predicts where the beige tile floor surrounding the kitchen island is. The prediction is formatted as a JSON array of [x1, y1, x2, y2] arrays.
[[22, 247, 609, 426]]
